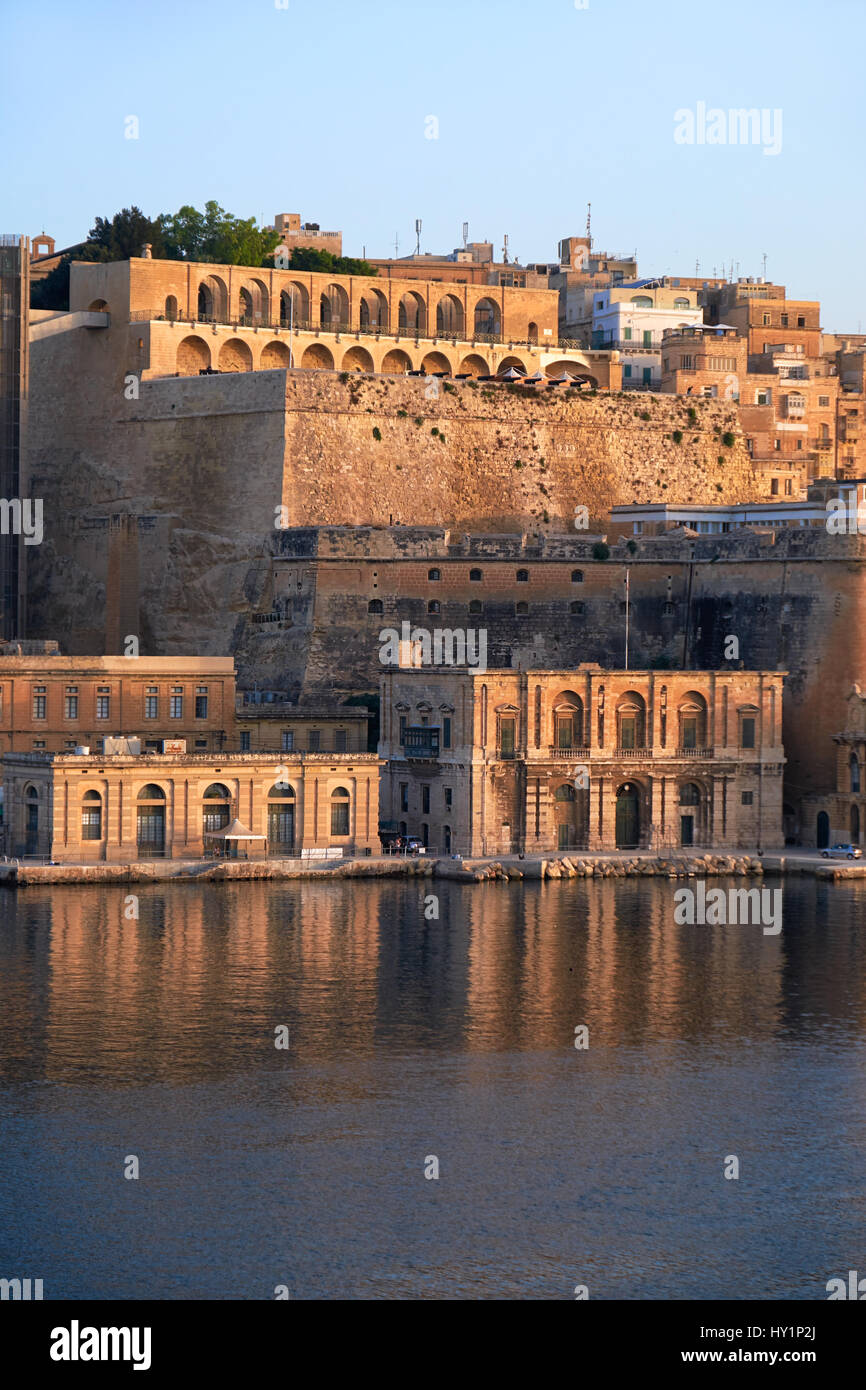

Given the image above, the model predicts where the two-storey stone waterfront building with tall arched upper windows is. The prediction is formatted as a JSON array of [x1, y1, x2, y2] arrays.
[[379, 663, 785, 855]]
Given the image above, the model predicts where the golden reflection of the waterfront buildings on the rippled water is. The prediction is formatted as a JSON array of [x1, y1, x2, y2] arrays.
[[0, 880, 866, 1084]]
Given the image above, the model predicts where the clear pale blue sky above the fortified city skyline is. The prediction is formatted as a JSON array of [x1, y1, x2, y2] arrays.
[[0, 0, 866, 331]]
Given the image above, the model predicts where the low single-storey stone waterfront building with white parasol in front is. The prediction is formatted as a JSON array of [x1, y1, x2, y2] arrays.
[[3, 752, 379, 863]]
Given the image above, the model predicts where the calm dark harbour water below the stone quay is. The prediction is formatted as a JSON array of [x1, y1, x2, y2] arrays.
[[0, 878, 866, 1298]]
